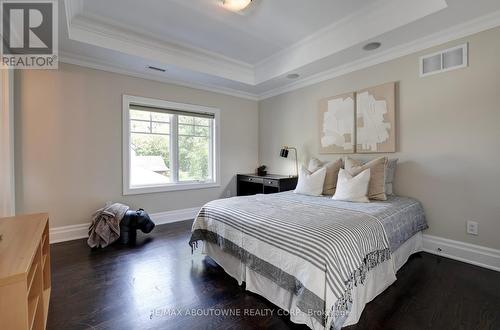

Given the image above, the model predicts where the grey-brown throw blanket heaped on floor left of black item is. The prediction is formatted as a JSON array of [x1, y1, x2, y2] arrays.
[[87, 202, 129, 248]]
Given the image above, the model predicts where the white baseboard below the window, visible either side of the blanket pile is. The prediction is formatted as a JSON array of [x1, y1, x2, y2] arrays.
[[50, 207, 200, 244]]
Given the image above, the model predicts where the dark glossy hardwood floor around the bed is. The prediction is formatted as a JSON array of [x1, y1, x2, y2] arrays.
[[48, 221, 500, 330]]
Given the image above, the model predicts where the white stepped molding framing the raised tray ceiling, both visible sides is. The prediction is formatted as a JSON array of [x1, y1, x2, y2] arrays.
[[65, 0, 447, 86]]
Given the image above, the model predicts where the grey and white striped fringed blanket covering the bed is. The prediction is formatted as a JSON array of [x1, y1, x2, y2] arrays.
[[189, 192, 427, 329]]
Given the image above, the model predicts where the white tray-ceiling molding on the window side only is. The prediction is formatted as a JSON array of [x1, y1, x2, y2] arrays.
[[64, 0, 255, 85]]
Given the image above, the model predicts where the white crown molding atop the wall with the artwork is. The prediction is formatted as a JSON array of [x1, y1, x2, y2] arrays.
[[259, 11, 500, 100]]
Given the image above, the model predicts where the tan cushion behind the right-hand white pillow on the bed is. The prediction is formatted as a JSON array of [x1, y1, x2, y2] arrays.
[[345, 157, 387, 201]]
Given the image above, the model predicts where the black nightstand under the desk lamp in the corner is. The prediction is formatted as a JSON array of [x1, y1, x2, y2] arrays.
[[236, 174, 297, 196]]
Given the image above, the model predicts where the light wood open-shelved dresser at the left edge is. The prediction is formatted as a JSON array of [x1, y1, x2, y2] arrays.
[[0, 214, 51, 330]]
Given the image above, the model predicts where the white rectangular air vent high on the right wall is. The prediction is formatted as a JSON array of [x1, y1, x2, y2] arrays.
[[420, 44, 468, 77]]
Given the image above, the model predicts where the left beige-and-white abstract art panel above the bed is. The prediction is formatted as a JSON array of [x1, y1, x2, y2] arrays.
[[319, 93, 355, 154]]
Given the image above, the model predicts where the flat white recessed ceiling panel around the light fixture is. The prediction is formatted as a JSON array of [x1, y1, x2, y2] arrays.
[[84, 0, 375, 64]]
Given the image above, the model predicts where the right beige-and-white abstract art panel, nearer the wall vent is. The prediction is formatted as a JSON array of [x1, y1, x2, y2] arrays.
[[356, 83, 396, 153]]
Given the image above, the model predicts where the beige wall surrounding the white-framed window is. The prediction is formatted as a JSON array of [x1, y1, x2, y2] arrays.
[[15, 64, 258, 227]]
